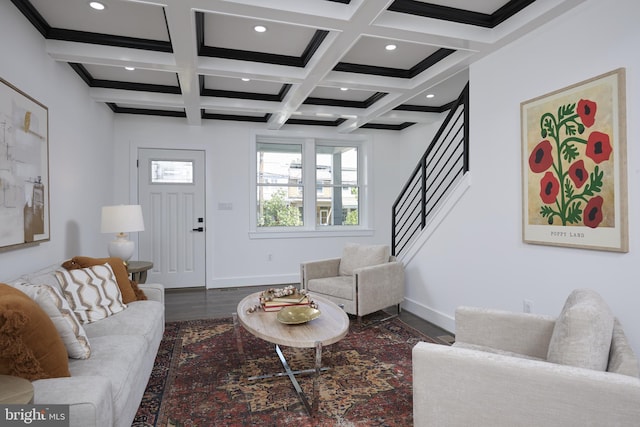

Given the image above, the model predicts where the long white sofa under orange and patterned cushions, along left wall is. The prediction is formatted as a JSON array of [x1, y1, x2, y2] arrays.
[[9, 264, 164, 427]]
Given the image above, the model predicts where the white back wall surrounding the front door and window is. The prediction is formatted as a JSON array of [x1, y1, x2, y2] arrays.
[[115, 115, 415, 287]]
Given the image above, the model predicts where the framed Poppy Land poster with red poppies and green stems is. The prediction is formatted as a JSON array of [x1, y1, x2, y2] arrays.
[[520, 68, 629, 252]]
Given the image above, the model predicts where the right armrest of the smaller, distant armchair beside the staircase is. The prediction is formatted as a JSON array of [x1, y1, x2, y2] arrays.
[[353, 261, 404, 314]]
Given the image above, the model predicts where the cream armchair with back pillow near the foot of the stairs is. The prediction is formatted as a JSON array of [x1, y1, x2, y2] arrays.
[[300, 244, 404, 318]]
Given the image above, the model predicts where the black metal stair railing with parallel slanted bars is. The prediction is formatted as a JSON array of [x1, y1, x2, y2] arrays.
[[391, 83, 469, 255]]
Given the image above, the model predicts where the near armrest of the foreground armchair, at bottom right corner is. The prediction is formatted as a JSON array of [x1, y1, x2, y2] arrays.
[[412, 343, 640, 427]]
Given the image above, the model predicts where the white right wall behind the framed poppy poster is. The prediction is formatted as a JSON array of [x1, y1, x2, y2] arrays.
[[404, 0, 640, 352]]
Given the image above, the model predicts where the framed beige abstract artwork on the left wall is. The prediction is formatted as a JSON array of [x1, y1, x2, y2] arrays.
[[0, 79, 50, 250]]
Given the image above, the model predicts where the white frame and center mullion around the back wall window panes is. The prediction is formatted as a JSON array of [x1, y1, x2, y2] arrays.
[[249, 133, 373, 239]]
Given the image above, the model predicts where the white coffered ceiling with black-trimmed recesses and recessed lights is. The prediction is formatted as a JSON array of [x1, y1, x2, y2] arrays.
[[11, 0, 584, 132]]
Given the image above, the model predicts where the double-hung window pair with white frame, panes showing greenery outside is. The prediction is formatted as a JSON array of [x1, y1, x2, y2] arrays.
[[251, 136, 371, 237]]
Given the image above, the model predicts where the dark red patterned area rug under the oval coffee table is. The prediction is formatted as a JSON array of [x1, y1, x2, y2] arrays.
[[133, 314, 435, 427]]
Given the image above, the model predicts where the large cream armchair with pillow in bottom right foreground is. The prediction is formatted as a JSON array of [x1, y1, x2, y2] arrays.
[[413, 291, 640, 427]]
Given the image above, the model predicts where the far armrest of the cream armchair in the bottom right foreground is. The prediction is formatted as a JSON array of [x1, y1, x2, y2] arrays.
[[456, 307, 555, 359]]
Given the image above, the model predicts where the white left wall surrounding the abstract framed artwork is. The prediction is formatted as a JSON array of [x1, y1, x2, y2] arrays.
[[0, 1, 113, 281]]
